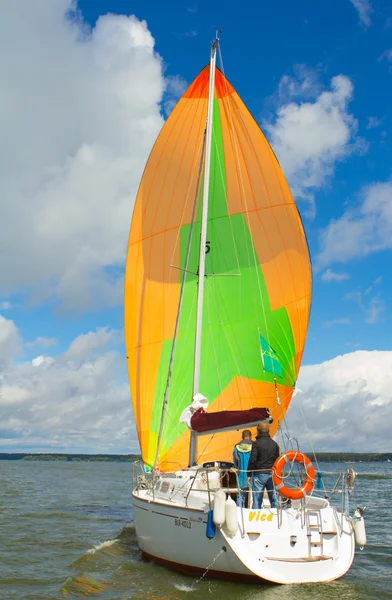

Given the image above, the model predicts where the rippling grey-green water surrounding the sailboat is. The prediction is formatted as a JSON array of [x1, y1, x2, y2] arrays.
[[0, 461, 392, 600]]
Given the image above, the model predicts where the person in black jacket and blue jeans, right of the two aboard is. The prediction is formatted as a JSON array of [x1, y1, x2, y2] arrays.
[[248, 423, 279, 508]]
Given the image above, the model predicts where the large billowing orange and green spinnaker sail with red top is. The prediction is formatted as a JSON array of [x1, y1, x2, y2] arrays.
[[125, 66, 311, 471]]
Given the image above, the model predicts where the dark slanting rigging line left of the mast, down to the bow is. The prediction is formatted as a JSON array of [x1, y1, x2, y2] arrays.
[[154, 134, 206, 470]]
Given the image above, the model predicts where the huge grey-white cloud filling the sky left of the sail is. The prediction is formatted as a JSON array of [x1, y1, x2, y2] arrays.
[[0, 0, 165, 310]]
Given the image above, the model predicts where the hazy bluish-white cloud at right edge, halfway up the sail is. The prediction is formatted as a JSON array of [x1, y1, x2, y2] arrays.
[[316, 182, 392, 268]]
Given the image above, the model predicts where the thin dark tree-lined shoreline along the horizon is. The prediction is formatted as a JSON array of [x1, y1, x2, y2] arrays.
[[0, 452, 392, 463]]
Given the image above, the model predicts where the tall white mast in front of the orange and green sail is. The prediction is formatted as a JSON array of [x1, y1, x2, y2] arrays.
[[189, 31, 219, 466]]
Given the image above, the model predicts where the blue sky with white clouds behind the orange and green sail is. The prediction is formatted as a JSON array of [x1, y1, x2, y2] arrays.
[[0, 0, 392, 452]]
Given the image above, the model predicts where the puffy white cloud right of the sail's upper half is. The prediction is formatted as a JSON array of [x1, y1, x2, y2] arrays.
[[264, 73, 357, 212]]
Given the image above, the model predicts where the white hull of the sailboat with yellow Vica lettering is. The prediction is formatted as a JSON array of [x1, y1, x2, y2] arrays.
[[133, 471, 355, 584]]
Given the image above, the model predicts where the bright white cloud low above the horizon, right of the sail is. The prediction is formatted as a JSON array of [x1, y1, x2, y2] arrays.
[[287, 351, 392, 452]]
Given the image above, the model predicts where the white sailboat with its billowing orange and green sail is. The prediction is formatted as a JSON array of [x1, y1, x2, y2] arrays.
[[124, 34, 366, 583]]
